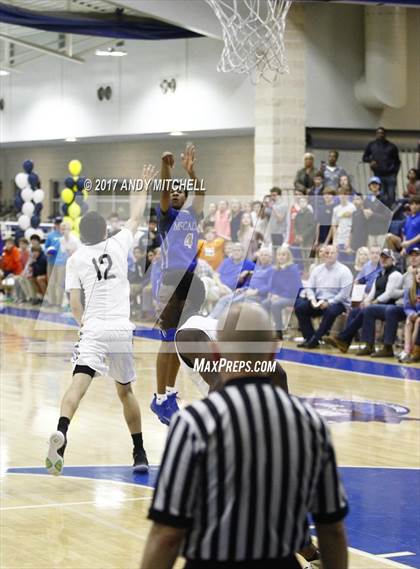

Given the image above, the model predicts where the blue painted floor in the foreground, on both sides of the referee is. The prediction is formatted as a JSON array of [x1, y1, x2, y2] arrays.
[[7, 466, 420, 569]]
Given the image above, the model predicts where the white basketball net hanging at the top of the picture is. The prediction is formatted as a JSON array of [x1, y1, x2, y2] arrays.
[[206, 0, 292, 83]]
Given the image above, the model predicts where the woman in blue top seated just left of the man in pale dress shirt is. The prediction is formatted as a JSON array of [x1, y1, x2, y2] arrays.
[[262, 245, 302, 340]]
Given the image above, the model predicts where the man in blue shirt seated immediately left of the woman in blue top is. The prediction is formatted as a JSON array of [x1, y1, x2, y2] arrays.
[[211, 247, 273, 318]]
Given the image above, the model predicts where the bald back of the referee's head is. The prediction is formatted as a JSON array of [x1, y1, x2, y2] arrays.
[[217, 302, 277, 375]]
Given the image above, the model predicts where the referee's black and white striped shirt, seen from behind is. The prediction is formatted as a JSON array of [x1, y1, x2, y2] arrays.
[[149, 377, 348, 567]]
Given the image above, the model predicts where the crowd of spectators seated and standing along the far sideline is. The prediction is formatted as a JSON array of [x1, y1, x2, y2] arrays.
[[0, 128, 420, 362]]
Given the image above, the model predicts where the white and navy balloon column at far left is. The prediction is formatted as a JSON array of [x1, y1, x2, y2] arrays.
[[15, 160, 45, 239]]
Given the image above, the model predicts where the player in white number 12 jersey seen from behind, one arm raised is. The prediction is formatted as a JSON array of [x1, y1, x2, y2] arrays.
[[45, 166, 154, 475]]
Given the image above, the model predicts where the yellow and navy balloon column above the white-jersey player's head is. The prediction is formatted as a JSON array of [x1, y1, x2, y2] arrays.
[[61, 160, 89, 235]]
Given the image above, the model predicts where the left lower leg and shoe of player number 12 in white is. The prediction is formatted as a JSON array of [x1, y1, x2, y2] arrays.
[[45, 365, 96, 476]]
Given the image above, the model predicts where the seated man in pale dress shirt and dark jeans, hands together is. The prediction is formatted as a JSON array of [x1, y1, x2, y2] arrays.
[[295, 245, 353, 349]]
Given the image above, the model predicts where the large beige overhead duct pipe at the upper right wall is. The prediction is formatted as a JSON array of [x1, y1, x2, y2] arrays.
[[354, 6, 408, 109]]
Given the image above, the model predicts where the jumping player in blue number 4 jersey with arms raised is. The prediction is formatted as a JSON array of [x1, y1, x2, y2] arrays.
[[150, 145, 204, 425]]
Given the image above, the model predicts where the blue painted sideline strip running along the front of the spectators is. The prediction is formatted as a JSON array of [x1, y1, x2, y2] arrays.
[[0, 306, 420, 381]]
